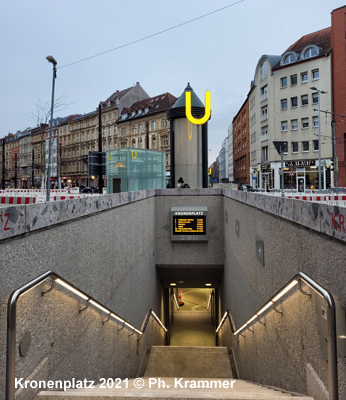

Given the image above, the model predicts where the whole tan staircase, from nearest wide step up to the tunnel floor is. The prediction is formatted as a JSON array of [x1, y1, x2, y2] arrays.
[[35, 346, 313, 400]]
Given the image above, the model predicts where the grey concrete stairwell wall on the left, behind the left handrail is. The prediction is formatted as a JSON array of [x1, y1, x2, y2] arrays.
[[0, 191, 164, 399]]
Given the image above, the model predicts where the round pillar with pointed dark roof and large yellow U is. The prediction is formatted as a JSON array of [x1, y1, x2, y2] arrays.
[[167, 84, 210, 189]]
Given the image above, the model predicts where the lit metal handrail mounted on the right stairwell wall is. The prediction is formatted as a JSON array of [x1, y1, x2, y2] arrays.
[[216, 272, 339, 400]]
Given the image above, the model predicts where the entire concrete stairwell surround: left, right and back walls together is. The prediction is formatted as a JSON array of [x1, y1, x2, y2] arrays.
[[0, 189, 346, 398]]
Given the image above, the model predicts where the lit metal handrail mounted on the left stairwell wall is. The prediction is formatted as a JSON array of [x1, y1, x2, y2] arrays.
[[6, 271, 167, 400]]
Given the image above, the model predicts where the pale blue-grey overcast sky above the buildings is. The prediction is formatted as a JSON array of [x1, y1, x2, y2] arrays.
[[0, 0, 345, 163]]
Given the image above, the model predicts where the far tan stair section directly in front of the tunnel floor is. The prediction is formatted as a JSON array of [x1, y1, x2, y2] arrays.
[[144, 346, 233, 378]]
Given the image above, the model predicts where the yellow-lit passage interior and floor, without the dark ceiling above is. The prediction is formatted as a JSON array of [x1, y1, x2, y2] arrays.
[[170, 288, 216, 346]]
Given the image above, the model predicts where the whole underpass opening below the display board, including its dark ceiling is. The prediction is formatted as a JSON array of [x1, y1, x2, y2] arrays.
[[156, 264, 224, 346]]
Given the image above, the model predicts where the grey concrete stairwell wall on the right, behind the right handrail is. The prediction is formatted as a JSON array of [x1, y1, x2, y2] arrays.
[[220, 190, 346, 398]]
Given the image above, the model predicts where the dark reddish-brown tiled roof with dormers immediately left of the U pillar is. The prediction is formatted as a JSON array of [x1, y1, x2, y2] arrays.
[[117, 92, 177, 122]]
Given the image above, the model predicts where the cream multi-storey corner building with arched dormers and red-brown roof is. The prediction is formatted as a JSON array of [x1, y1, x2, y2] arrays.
[[249, 28, 333, 190]]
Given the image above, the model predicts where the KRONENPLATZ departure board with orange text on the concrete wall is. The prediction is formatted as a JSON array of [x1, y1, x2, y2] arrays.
[[171, 207, 208, 241]]
